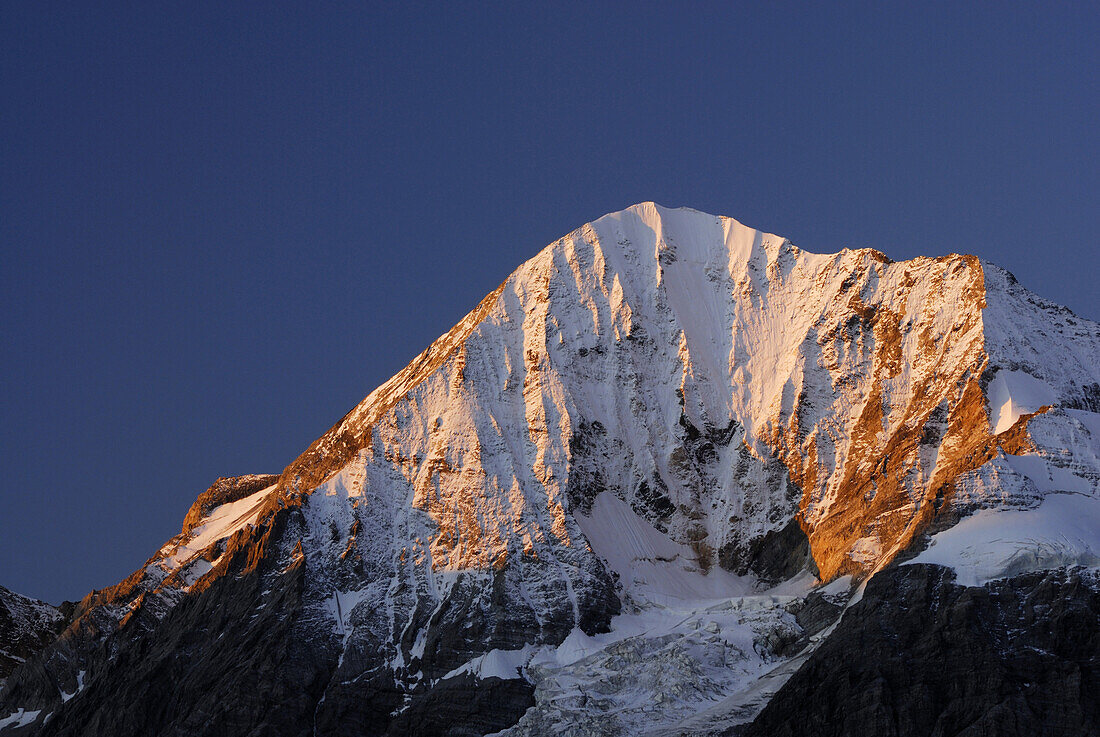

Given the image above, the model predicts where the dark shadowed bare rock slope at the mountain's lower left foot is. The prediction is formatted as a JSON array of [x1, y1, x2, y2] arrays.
[[6, 510, 534, 737]]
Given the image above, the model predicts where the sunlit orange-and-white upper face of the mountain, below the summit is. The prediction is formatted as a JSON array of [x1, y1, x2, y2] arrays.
[[283, 204, 1100, 580]]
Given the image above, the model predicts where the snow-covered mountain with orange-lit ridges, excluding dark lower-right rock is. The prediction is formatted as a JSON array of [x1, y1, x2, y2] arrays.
[[0, 202, 1100, 735]]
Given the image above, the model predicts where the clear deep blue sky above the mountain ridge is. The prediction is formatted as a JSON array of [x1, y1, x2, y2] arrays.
[[0, 2, 1100, 602]]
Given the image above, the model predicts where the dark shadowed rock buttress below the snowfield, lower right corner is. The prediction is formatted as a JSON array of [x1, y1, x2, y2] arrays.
[[730, 565, 1100, 737]]
